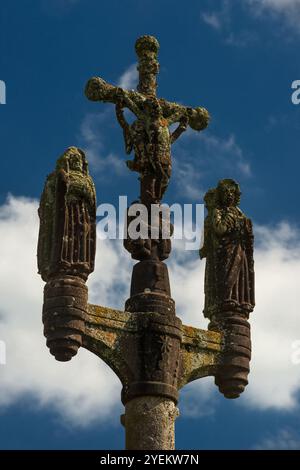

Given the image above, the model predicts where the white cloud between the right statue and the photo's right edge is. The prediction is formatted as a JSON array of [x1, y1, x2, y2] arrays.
[[242, 223, 300, 409]]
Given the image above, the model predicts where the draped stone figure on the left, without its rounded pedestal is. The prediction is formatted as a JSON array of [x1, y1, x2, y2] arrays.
[[38, 147, 96, 281]]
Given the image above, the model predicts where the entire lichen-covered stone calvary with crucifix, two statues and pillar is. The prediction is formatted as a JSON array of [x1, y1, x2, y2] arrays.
[[38, 36, 254, 450]]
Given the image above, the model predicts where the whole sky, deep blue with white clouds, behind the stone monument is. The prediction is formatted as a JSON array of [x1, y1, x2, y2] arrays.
[[0, 0, 300, 449]]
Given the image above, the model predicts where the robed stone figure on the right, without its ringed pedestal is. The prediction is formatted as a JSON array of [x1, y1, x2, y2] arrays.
[[200, 180, 255, 318]]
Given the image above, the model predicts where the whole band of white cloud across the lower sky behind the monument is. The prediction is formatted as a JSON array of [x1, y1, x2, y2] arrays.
[[0, 196, 300, 425]]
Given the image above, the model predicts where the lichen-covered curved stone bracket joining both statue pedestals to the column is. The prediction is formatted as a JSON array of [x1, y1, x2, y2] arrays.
[[82, 304, 224, 401]]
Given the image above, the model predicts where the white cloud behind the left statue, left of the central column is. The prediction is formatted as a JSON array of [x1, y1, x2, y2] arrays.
[[0, 197, 127, 425]]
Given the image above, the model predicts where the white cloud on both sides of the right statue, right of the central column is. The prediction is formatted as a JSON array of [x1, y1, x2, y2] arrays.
[[169, 218, 300, 410]]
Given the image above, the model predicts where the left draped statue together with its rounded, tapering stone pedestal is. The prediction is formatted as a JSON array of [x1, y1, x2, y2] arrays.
[[38, 147, 96, 361]]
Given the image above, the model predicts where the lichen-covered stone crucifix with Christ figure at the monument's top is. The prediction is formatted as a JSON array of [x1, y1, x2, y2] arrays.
[[85, 36, 209, 205]]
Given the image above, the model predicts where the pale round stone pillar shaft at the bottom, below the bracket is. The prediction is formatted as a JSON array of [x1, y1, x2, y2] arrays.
[[123, 395, 179, 450]]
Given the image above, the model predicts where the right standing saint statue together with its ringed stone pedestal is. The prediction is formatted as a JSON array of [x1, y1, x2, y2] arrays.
[[200, 179, 255, 398]]
